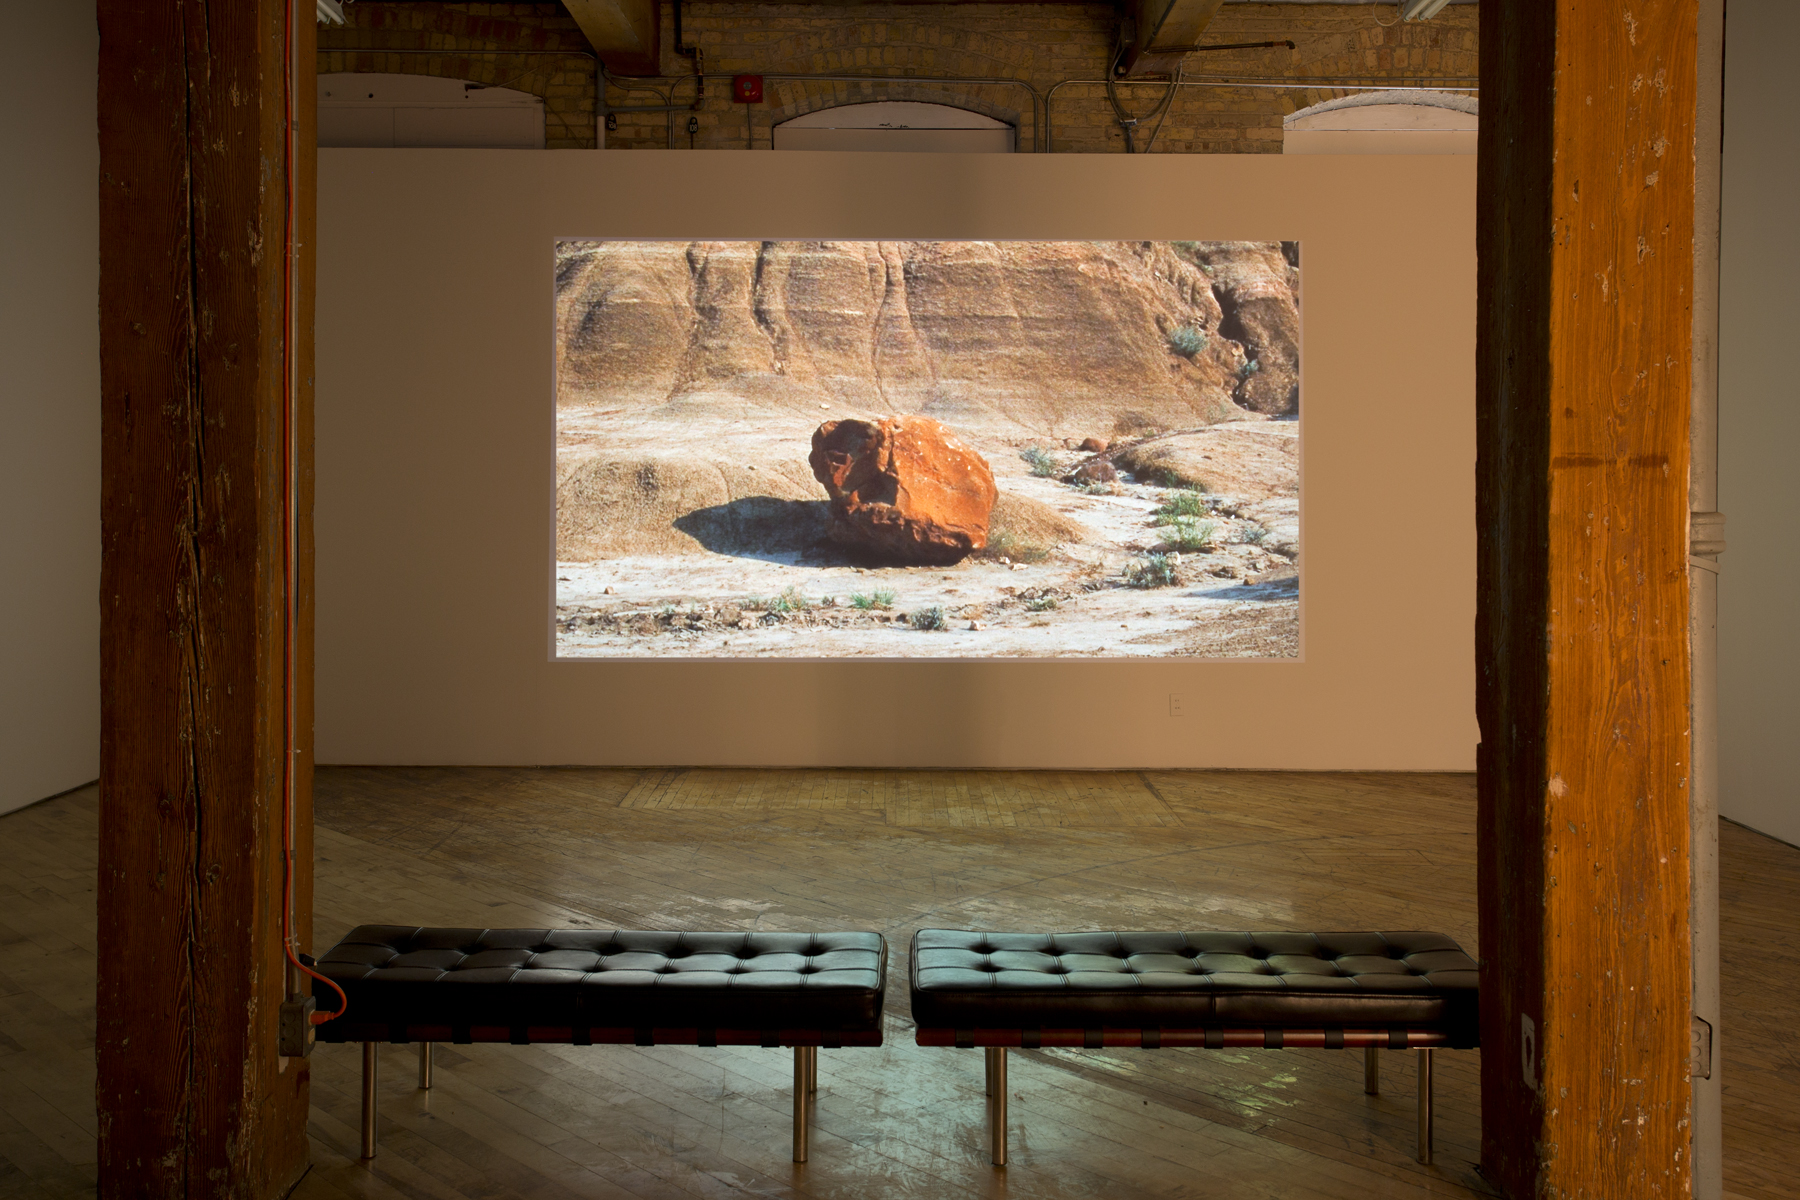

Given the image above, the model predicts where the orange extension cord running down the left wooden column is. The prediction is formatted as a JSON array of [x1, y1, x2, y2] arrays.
[[281, 0, 349, 1025]]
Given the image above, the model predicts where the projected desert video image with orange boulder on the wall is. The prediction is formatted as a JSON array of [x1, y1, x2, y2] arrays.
[[554, 239, 1300, 658]]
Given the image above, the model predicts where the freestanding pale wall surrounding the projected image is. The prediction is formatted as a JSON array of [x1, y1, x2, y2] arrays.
[[317, 149, 1476, 770]]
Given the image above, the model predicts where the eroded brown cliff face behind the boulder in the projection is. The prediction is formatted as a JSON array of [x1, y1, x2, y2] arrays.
[[556, 241, 1300, 437]]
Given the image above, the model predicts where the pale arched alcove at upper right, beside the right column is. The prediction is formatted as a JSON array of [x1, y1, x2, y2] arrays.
[[1282, 90, 1480, 155]]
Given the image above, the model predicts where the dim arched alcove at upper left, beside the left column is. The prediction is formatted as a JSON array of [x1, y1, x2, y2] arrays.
[[319, 72, 544, 149]]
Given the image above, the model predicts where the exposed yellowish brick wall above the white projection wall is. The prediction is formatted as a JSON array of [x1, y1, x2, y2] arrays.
[[319, 4, 1478, 153]]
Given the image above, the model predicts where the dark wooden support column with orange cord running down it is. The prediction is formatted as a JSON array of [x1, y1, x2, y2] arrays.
[[95, 0, 315, 1200]]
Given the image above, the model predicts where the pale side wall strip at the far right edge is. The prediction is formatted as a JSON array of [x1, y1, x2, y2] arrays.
[[1719, 0, 1800, 844]]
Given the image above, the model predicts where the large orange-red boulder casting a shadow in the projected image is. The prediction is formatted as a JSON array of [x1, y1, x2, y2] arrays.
[[808, 416, 997, 563]]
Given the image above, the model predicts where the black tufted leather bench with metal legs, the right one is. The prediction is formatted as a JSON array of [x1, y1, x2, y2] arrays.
[[911, 928, 1478, 1166]]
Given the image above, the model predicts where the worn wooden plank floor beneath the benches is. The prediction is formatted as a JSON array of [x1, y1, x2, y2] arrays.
[[0, 768, 1800, 1200]]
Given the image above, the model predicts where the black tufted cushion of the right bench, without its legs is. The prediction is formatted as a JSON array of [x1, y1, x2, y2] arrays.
[[913, 928, 1478, 1047]]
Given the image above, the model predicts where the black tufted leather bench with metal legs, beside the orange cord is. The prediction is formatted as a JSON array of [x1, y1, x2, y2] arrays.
[[315, 925, 887, 1162]]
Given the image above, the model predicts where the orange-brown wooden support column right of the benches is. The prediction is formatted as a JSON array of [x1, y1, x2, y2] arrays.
[[1476, 0, 1697, 1200]]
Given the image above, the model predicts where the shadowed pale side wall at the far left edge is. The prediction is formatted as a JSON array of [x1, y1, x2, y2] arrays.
[[0, 0, 101, 811]]
